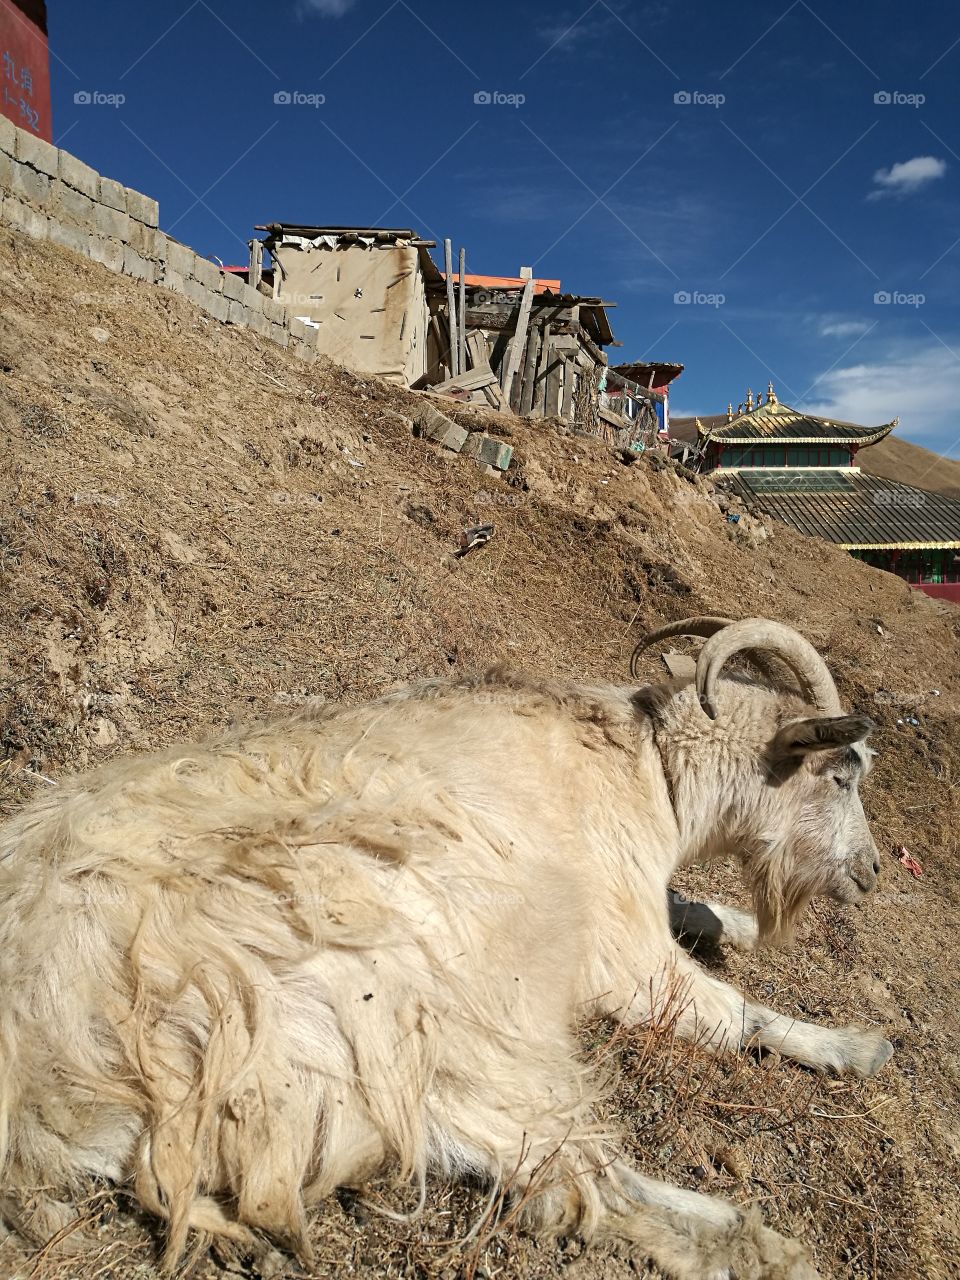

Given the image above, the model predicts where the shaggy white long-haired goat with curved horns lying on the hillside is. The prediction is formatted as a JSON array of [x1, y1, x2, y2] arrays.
[[0, 621, 891, 1280]]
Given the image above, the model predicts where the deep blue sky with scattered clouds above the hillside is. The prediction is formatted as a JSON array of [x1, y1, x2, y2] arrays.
[[43, 0, 960, 457]]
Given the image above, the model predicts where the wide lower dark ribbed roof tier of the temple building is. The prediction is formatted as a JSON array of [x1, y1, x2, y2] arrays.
[[727, 467, 960, 550]]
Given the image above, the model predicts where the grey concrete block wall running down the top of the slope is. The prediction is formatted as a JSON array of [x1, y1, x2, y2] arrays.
[[0, 115, 317, 361]]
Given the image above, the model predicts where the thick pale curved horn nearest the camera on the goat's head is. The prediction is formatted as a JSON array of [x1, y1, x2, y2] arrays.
[[696, 618, 844, 719]]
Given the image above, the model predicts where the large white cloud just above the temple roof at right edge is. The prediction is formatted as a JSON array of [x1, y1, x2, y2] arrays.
[[803, 343, 960, 456]]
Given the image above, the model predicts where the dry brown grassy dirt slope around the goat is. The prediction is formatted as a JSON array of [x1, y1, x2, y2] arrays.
[[0, 233, 960, 1280]]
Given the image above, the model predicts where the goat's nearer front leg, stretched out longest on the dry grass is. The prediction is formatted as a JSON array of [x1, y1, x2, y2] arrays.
[[628, 947, 893, 1076]]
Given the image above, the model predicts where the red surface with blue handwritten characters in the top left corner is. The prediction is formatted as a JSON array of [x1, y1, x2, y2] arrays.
[[0, 0, 52, 142]]
